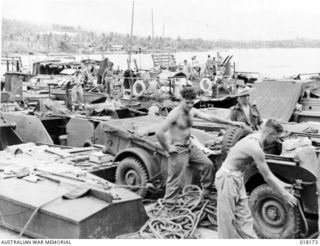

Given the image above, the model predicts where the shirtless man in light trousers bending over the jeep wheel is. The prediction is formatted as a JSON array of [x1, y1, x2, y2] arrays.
[[215, 119, 297, 239]]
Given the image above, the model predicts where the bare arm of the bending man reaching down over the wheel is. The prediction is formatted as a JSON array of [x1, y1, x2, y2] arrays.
[[248, 144, 297, 206]]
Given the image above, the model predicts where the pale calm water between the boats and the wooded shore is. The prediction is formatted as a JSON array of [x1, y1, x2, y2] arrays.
[[2, 48, 320, 78]]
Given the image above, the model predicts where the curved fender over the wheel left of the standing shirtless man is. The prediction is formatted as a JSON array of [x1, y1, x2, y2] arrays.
[[113, 147, 162, 182]]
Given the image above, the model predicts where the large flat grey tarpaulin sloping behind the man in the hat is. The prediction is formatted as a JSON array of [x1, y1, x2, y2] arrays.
[[251, 81, 302, 121]]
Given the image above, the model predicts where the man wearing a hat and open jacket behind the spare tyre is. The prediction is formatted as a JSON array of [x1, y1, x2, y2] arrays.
[[230, 88, 262, 131]]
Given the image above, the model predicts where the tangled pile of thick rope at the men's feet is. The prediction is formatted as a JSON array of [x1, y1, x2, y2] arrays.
[[118, 185, 217, 239]]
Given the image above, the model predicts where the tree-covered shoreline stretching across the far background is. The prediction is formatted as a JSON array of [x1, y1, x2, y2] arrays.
[[2, 19, 320, 54]]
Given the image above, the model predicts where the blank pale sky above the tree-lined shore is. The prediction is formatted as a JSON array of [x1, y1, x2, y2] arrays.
[[2, 0, 320, 40]]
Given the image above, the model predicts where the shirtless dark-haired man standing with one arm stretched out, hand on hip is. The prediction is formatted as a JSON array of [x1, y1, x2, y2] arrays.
[[157, 86, 244, 206]]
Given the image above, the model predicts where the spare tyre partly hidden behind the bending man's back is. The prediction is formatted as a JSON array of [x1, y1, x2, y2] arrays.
[[222, 126, 252, 152]]
